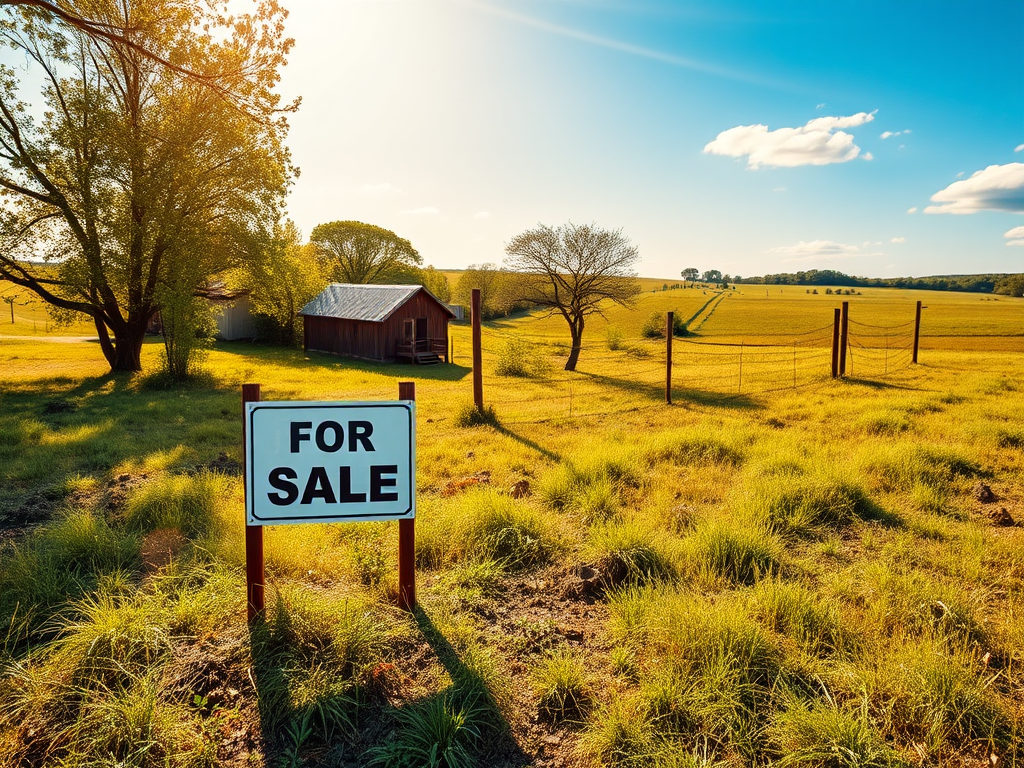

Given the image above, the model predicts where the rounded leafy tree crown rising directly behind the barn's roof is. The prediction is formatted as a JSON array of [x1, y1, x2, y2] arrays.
[[309, 221, 423, 285]]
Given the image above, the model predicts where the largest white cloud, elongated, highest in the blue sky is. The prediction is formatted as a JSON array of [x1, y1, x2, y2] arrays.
[[703, 112, 874, 169]]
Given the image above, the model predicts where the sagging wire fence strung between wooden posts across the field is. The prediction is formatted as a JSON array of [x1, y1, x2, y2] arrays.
[[468, 296, 920, 425]]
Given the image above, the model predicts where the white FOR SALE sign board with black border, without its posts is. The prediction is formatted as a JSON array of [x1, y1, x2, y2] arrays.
[[245, 400, 416, 525]]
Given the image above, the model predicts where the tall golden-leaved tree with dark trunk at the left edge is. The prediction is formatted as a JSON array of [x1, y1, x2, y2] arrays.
[[0, 0, 291, 371]]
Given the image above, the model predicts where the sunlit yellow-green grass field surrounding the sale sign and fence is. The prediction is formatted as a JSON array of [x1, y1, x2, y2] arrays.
[[0, 281, 1024, 768]]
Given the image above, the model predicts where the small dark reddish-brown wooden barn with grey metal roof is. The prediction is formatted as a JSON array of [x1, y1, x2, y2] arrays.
[[299, 283, 455, 365]]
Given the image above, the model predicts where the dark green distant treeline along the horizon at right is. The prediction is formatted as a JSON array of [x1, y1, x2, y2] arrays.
[[732, 269, 1024, 296]]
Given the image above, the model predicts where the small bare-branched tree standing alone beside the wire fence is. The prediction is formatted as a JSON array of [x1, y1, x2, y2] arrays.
[[505, 222, 640, 371]]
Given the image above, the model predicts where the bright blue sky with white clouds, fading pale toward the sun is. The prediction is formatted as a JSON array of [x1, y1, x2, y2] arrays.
[[282, 0, 1024, 278]]
